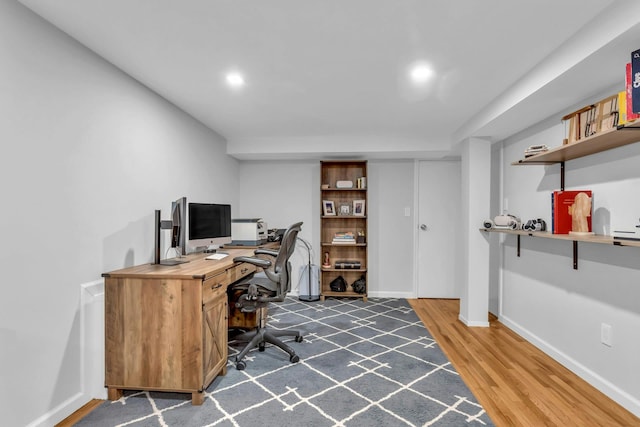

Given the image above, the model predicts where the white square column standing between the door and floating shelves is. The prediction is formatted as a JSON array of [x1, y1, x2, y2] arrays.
[[459, 138, 491, 327]]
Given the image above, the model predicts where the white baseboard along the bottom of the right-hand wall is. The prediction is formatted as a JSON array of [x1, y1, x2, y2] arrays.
[[498, 315, 640, 417]]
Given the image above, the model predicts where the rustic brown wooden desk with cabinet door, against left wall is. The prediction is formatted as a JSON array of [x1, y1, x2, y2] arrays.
[[103, 249, 256, 405]]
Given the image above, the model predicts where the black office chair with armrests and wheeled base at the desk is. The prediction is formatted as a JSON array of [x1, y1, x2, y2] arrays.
[[233, 222, 303, 370]]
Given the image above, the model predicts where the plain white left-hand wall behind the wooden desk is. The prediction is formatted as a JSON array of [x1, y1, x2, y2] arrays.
[[0, 0, 238, 426]]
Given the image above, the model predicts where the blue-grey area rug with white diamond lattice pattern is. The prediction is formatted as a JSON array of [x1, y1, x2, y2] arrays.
[[76, 298, 493, 427]]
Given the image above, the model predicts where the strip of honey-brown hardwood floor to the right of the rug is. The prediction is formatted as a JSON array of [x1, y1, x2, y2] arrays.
[[409, 299, 640, 427]]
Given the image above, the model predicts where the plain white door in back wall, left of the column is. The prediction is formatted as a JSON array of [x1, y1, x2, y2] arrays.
[[417, 161, 462, 298]]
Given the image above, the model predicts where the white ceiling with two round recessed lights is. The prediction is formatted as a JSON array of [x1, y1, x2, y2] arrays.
[[21, 0, 640, 159]]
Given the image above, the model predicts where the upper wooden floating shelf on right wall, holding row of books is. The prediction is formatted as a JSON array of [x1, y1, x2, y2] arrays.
[[511, 120, 640, 166]]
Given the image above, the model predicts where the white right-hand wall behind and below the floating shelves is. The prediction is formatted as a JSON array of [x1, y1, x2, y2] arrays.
[[500, 117, 640, 416]]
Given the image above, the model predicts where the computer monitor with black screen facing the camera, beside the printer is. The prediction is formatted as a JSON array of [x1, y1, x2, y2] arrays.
[[187, 203, 231, 252]]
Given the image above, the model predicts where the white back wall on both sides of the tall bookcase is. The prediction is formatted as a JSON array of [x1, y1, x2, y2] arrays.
[[238, 160, 415, 297]]
